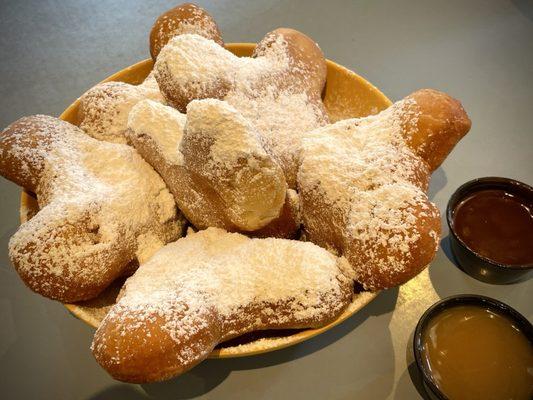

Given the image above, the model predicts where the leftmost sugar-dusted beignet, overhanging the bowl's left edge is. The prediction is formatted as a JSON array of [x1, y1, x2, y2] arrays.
[[0, 115, 185, 302]]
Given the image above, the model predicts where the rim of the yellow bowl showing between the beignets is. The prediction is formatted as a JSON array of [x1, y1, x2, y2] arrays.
[[20, 43, 392, 358]]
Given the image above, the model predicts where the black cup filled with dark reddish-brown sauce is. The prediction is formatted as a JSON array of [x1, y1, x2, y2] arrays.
[[446, 177, 533, 284]]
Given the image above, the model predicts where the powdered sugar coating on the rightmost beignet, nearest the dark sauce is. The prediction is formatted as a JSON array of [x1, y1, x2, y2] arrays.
[[298, 100, 438, 287]]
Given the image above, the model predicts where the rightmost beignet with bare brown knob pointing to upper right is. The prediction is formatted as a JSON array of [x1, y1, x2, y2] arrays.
[[298, 89, 470, 290]]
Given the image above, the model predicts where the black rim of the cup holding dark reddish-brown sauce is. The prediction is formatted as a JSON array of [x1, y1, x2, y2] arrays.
[[446, 176, 533, 273]]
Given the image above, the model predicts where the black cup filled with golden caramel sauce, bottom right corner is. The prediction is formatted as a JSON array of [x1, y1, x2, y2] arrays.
[[413, 295, 533, 400]]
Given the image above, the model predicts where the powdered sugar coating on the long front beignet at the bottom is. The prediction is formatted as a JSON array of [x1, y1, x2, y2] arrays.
[[95, 228, 351, 364]]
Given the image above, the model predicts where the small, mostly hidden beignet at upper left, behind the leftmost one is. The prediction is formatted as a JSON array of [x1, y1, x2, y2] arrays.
[[78, 73, 164, 143]]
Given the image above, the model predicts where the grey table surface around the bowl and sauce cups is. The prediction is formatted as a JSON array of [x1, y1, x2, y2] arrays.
[[0, 0, 533, 400]]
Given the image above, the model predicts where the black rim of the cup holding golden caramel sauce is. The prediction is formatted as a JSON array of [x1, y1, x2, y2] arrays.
[[413, 294, 533, 400]]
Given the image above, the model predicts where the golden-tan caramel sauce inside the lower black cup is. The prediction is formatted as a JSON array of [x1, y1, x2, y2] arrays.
[[422, 306, 533, 400]]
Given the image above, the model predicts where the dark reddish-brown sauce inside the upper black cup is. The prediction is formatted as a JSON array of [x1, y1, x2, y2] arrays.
[[453, 189, 533, 265]]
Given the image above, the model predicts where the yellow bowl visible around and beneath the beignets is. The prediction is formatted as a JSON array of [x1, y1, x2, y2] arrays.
[[20, 43, 391, 358]]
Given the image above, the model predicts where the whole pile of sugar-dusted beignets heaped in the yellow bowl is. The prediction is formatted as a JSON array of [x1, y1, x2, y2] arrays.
[[0, 4, 470, 382]]
